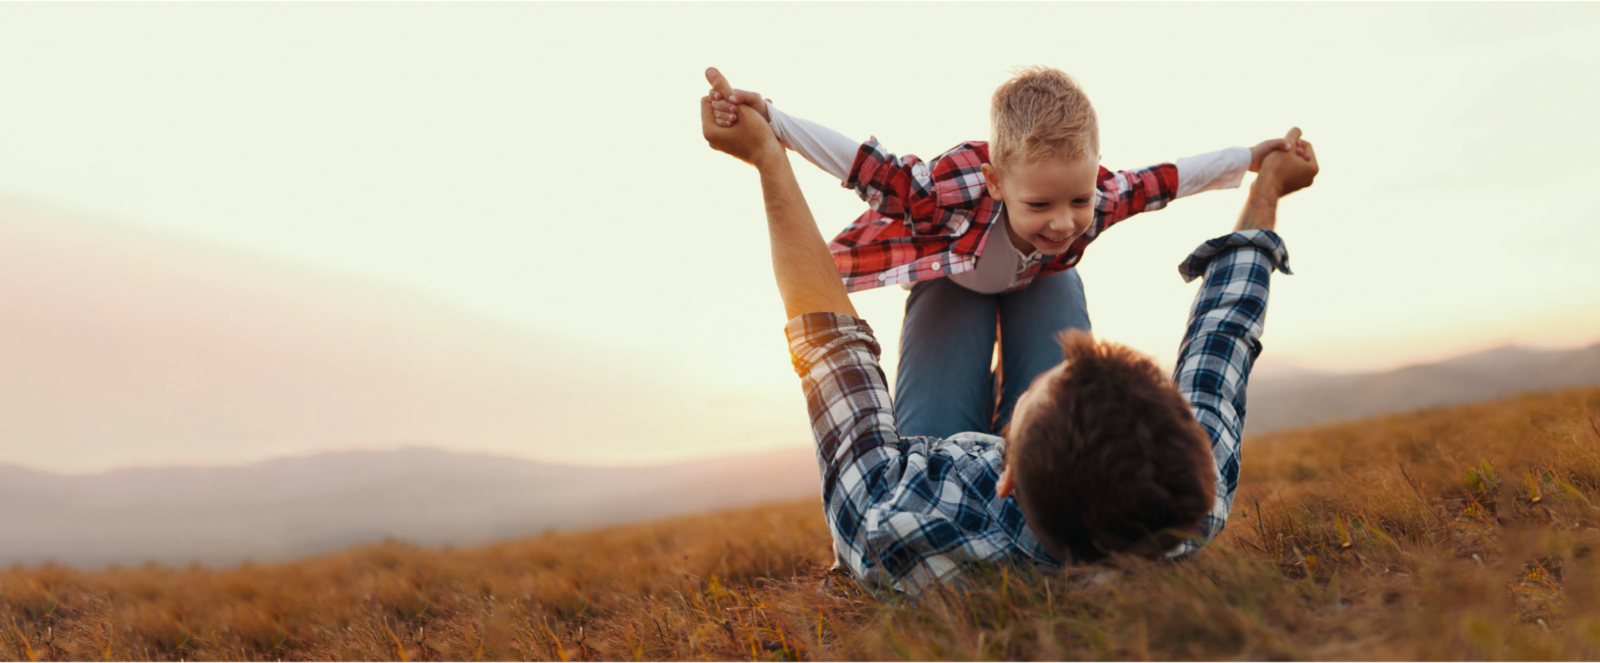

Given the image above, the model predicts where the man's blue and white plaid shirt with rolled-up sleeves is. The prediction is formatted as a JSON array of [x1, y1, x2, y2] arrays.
[[784, 231, 1290, 591]]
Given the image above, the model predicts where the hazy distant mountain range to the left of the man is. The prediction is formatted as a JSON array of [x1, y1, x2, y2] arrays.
[[0, 448, 821, 567]]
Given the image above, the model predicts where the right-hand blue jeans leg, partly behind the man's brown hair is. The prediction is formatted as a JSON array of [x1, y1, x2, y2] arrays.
[[994, 269, 1090, 431]]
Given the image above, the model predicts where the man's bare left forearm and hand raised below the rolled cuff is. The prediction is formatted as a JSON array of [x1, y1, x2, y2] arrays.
[[701, 69, 856, 319]]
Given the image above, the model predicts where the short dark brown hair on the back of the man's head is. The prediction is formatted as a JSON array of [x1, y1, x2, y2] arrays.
[[1008, 330, 1216, 564]]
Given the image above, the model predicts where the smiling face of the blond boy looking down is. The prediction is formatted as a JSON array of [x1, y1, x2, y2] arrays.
[[982, 154, 1099, 256]]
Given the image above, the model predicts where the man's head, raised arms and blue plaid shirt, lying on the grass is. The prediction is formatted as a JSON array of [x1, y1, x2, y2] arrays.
[[701, 70, 1317, 591]]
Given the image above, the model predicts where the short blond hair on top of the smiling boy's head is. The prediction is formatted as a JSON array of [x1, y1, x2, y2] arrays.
[[989, 67, 1099, 168]]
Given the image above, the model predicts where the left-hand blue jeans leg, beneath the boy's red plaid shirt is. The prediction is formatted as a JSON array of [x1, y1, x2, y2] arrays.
[[894, 279, 997, 437]]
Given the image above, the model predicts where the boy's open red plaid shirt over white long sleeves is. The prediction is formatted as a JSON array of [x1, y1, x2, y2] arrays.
[[827, 138, 1178, 291]]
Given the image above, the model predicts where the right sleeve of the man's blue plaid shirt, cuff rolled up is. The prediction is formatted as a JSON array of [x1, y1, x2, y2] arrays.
[[1173, 231, 1293, 553]]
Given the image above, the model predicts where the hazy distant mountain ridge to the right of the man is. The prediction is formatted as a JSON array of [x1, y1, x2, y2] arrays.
[[1245, 344, 1600, 434]]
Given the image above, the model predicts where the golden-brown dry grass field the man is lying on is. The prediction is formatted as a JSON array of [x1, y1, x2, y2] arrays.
[[0, 389, 1600, 660]]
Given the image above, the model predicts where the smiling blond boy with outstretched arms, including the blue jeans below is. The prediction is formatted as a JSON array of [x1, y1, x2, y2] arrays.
[[707, 67, 1304, 437]]
